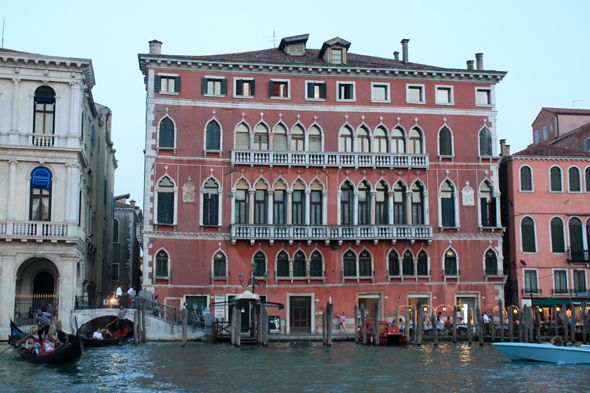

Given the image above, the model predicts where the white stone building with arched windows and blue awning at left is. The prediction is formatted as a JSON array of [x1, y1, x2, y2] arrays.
[[0, 49, 116, 339]]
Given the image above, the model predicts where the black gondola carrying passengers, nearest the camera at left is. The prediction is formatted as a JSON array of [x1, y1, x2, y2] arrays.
[[8, 321, 82, 365]]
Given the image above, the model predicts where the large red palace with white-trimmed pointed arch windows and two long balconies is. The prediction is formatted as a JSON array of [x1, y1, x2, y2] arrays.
[[139, 35, 506, 333]]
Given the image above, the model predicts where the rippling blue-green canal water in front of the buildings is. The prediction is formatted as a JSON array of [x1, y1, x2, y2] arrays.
[[0, 342, 590, 393]]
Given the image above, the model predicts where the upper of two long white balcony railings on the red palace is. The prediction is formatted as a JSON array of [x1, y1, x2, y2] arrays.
[[231, 150, 429, 168]]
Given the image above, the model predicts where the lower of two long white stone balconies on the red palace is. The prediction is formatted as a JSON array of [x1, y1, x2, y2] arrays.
[[231, 224, 432, 244]]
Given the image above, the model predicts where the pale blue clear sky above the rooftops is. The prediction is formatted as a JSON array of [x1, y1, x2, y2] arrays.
[[0, 0, 590, 211]]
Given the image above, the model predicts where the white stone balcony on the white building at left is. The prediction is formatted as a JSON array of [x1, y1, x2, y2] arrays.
[[0, 220, 81, 243]]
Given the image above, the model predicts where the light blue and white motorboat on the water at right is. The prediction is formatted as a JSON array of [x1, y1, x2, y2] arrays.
[[492, 343, 590, 363]]
